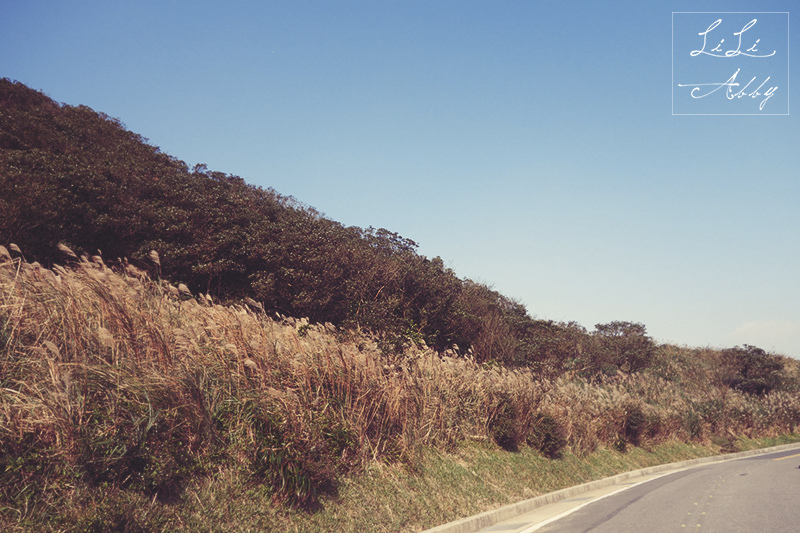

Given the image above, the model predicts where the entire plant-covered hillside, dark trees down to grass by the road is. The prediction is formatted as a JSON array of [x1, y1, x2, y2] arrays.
[[0, 80, 800, 531]]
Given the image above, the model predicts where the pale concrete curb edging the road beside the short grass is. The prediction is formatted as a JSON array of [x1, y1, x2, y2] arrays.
[[423, 442, 800, 533]]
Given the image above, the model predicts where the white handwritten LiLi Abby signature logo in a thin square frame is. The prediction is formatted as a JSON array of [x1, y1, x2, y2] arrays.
[[673, 13, 788, 114]]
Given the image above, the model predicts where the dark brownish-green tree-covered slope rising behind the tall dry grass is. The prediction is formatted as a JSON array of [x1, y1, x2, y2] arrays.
[[0, 80, 555, 364]]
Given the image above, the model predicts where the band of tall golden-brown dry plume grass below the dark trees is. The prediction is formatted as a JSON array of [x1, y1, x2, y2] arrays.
[[0, 245, 800, 529]]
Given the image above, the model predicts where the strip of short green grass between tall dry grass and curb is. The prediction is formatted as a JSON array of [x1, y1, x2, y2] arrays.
[[0, 434, 800, 533]]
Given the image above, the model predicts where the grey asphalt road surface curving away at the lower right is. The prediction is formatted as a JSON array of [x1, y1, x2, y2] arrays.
[[532, 450, 800, 533]]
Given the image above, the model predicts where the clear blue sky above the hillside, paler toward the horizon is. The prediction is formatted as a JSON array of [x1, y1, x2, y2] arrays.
[[0, 0, 800, 357]]
